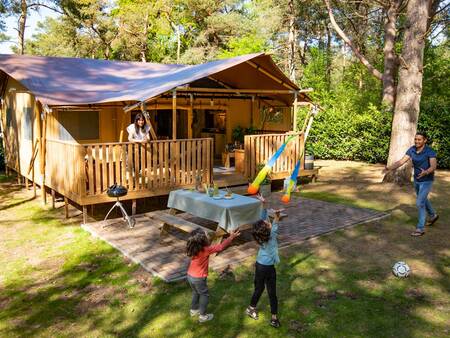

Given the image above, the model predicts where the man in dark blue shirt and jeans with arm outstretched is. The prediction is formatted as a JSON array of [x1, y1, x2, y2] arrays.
[[385, 132, 439, 236]]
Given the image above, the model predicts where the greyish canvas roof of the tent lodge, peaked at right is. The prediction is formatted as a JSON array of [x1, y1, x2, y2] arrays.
[[0, 53, 303, 106]]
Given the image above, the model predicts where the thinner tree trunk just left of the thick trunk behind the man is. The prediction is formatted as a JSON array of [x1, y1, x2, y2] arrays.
[[382, 0, 401, 112]]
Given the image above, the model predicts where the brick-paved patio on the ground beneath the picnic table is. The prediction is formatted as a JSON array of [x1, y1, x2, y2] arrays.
[[83, 193, 388, 282]]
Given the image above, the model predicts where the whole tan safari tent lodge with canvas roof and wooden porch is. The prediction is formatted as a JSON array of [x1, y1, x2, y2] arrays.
[[0, 53, 318, 222]]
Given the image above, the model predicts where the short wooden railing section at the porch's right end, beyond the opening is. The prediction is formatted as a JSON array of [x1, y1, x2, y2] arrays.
[[244, 133, 304, 179]]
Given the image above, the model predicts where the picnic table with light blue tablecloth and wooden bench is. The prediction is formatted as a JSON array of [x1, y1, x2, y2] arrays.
[[149, 189, 262, 240]]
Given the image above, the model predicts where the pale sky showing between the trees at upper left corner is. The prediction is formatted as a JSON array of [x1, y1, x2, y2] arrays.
[[0, 8, 59, 54]]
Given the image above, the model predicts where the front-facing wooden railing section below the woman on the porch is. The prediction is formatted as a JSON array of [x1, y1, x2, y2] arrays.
[[82, 138, 213, 202]]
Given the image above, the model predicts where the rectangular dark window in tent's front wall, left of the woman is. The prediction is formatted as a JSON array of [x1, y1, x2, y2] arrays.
[[58, 110, 100, 141]]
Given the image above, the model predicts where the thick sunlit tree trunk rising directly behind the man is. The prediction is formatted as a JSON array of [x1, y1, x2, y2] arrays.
[[383, 0, 430, 184]]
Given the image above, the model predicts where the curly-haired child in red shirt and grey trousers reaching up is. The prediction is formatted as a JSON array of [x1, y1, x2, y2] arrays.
[[186, 229, 240, 323]]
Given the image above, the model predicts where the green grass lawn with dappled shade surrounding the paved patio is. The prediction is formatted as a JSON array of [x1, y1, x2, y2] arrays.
[[0, 164, 450, 337]]
